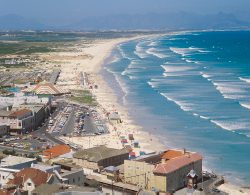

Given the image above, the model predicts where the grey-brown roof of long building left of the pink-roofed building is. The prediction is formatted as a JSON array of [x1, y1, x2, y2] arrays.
[[73, 146, 129, 162]]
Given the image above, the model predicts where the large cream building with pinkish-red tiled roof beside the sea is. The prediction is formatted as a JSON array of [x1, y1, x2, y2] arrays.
[[124, 150, 202, 193]]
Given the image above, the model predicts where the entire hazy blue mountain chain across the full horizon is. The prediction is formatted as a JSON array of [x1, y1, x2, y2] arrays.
[[0, 12, 250, 30]]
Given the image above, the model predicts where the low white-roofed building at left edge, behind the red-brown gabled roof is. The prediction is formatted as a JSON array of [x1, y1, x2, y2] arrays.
[[0, 156, 37, 170]]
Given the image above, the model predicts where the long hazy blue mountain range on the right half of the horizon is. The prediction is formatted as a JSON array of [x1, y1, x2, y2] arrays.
[[66, 12, 250, 30]]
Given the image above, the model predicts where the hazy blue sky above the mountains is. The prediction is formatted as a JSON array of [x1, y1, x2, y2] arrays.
[[0, 0, 250, 25]]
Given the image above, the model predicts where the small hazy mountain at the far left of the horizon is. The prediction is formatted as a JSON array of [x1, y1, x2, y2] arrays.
[[0, 14, 47, 30]]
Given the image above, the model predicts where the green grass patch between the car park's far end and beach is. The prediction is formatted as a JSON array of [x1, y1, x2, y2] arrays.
[[70, 90, 97, 106]]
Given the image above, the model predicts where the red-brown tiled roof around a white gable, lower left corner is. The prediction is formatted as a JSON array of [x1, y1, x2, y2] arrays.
[[8, 168, 51, 186]]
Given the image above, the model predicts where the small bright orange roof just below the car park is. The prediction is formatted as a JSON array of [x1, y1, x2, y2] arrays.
[[43, 145, 71, 158]]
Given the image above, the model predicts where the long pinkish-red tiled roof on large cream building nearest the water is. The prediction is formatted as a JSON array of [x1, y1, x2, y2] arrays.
[[153, 153, 202, 174]]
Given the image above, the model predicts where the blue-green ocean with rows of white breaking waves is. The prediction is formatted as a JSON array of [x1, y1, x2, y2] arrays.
[[102, 31, 250, 185]]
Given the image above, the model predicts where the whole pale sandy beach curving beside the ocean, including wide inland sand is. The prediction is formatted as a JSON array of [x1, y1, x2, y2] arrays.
[[41, 36, 250, 195]]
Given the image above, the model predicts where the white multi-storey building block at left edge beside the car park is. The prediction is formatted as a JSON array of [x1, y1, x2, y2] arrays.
[[0, 93, 51, 134]]
